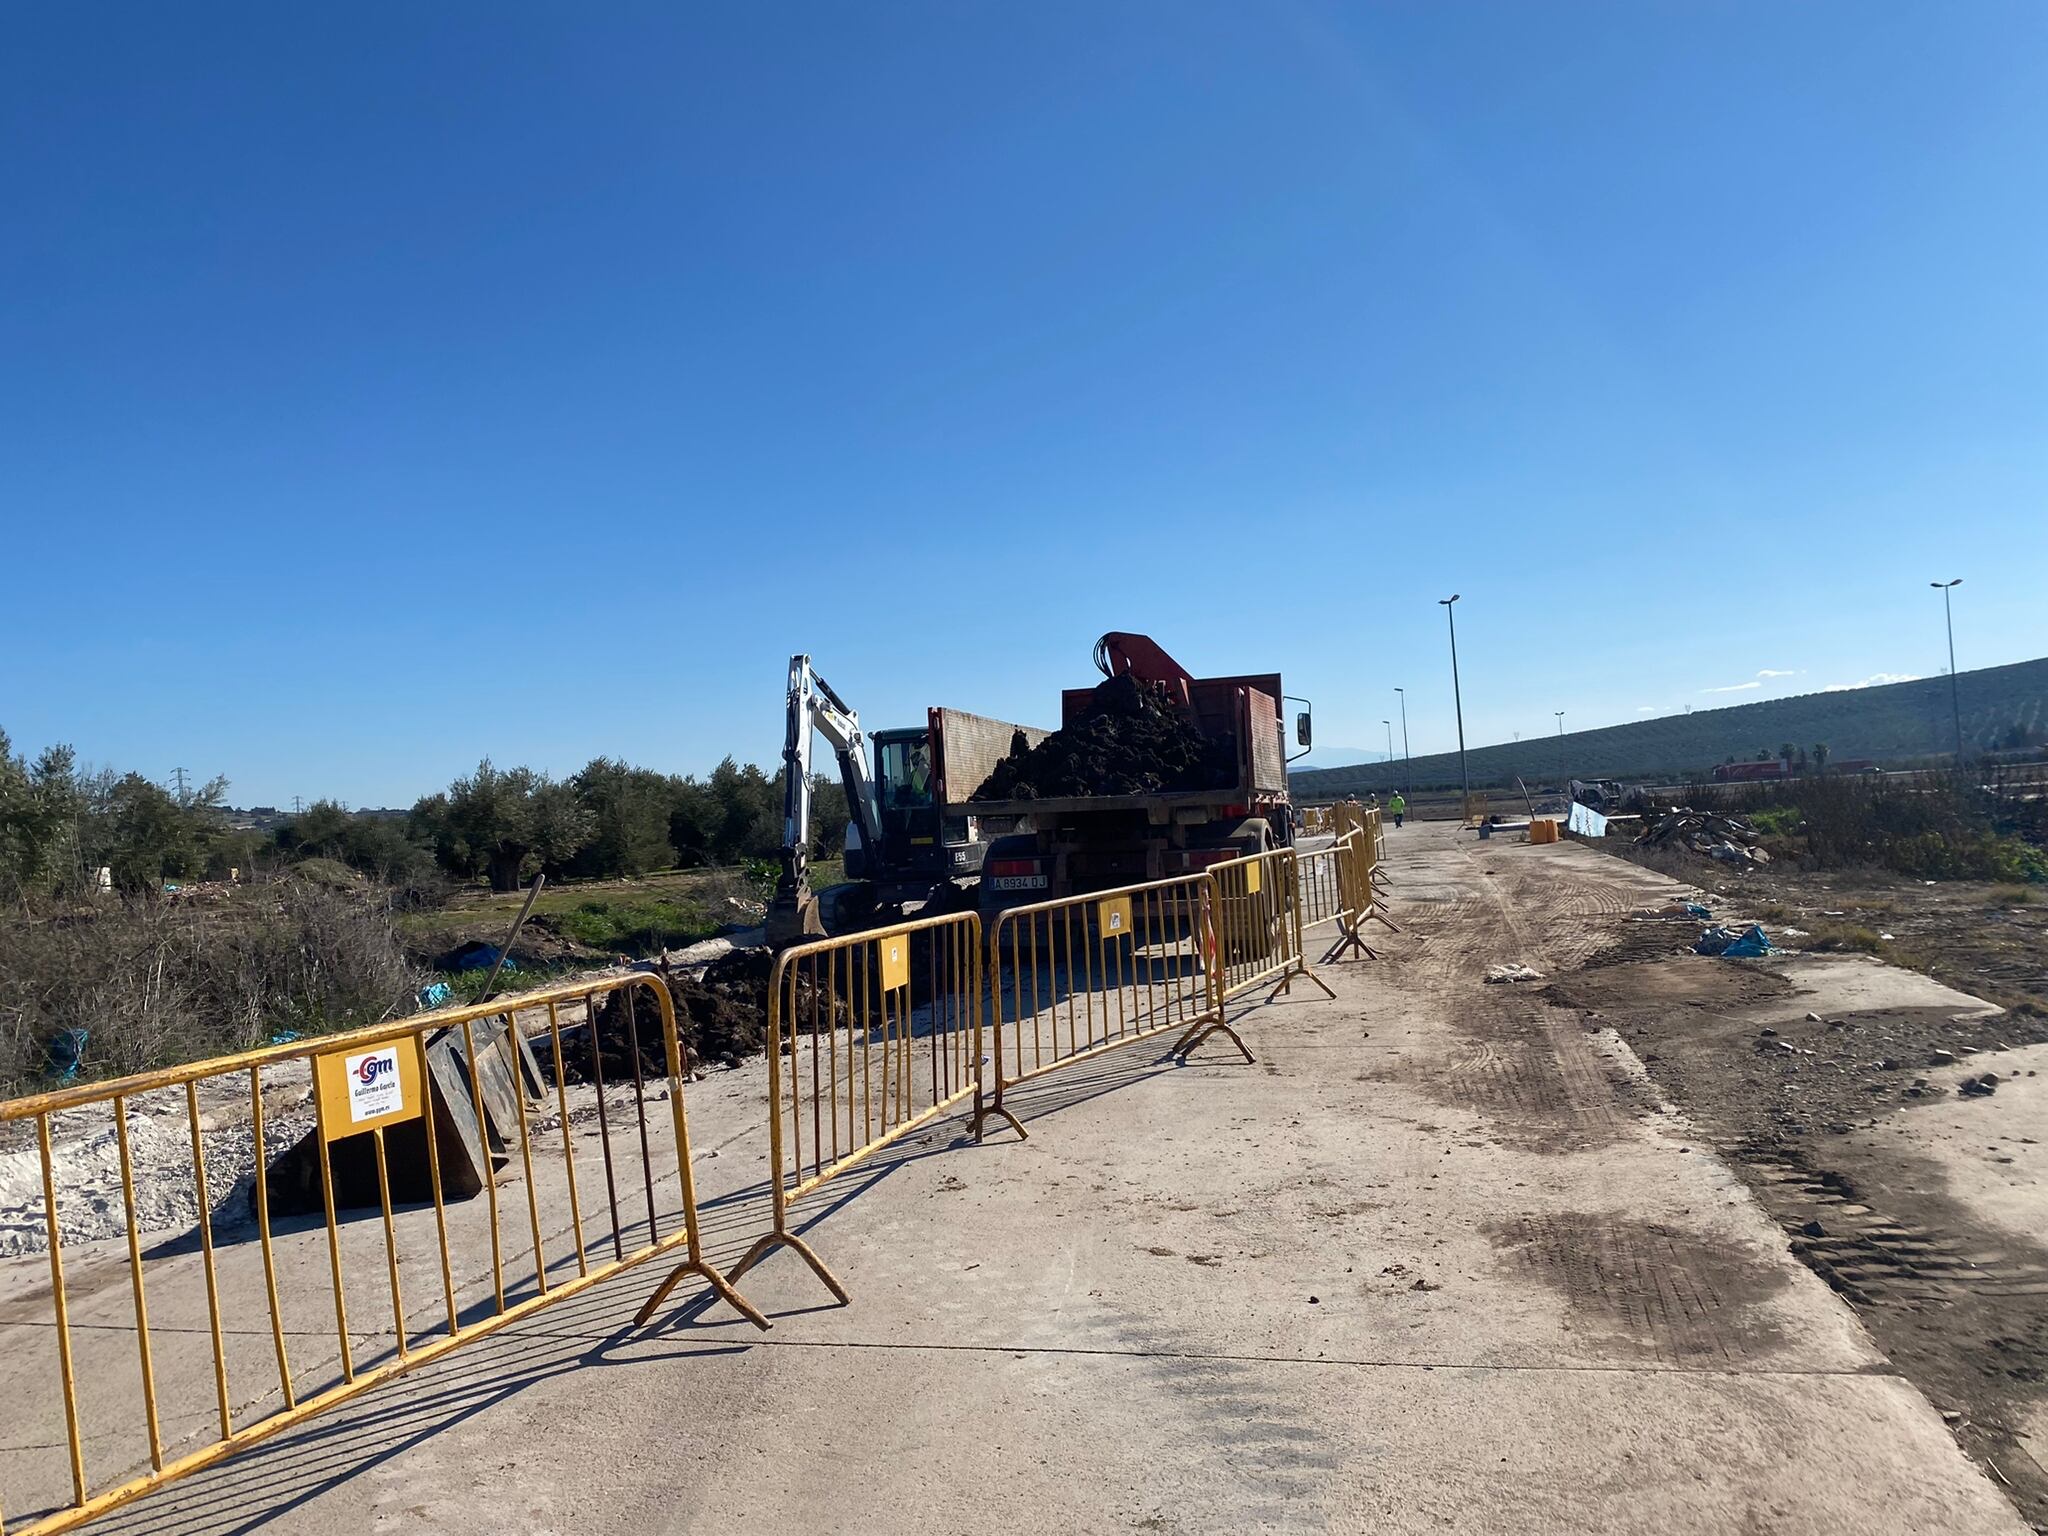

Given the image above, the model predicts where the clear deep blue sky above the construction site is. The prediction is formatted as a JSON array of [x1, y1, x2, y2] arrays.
[[0, 0, 2048, 805]]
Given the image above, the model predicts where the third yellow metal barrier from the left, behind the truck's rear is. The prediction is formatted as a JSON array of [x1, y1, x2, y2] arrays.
[[975, 874, 1253, 1137]]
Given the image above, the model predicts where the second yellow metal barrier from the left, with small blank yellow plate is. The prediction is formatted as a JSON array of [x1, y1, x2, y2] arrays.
[[641, 911, 981, 1321]]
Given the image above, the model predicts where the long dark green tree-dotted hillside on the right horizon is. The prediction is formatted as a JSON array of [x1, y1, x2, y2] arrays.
[[1288, 657, 2048, 799]]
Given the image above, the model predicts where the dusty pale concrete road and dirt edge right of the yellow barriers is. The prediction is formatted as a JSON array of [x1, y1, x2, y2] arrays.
[[0, 823, 2048, 1536]]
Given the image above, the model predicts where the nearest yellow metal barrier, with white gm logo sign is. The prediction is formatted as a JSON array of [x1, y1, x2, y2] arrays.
[[0, 975, 768, 1536]]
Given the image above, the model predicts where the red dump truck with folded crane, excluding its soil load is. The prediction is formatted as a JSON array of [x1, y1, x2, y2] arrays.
[[958, 633, 1311, 922]]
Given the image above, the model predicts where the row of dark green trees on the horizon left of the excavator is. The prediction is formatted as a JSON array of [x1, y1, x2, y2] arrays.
[[0, 731, 846, 901]]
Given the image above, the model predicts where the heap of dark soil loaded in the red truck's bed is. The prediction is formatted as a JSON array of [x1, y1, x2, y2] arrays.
[[973, 674, 1237, 801]]
